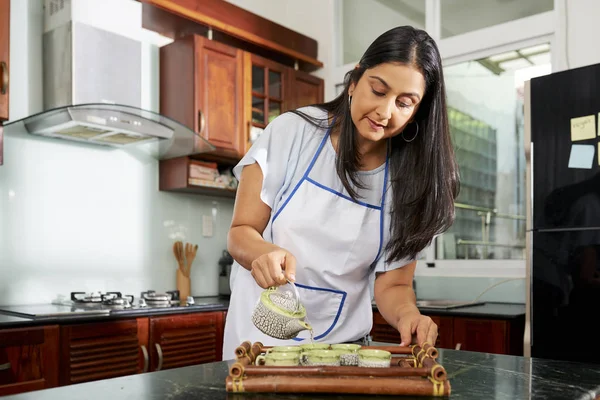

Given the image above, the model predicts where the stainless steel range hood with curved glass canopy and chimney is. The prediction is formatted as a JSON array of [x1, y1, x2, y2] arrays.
[[4, 0, 215, 159]]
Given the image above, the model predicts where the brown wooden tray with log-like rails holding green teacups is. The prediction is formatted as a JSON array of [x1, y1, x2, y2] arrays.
[[225, 341, 451, 397]]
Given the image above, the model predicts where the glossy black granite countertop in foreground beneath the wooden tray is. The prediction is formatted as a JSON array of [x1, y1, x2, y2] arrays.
[[3, 343, 600, 400]]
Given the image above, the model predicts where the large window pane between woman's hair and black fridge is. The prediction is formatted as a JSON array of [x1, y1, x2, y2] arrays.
[[436, 44, 551, 259]]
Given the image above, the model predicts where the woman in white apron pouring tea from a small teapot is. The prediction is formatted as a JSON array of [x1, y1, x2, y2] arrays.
[[223, 26, 458, 359]]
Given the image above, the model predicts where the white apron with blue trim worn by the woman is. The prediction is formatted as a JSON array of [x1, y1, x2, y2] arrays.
[[223, 128, 389, 360]]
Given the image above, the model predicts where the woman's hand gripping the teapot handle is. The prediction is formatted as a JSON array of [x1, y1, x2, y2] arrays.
[[250, 249, 296, 289]]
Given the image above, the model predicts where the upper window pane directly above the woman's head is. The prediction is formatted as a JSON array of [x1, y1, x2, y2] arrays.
[[338, 0, 425, 65]]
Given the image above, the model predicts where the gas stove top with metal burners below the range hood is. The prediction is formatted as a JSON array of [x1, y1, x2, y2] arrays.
[[0, 290, 222, 319]]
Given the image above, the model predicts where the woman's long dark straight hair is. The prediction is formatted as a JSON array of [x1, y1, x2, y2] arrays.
[[292, 26, 460, 262]]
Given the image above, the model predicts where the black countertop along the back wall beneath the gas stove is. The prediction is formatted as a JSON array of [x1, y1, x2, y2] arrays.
[[0, 296, 229, 329]]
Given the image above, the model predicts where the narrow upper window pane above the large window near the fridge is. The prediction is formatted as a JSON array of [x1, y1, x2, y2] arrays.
[[441, 0, 554, 38]]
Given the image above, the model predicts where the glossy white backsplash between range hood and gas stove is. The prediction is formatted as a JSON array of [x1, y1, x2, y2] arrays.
[[0, 135, 233, 304]]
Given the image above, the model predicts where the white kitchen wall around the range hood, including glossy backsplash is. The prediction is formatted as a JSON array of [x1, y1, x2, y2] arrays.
[[0, 0, 333, 305]]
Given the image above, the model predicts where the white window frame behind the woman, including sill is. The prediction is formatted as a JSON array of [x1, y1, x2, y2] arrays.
[[330, 0, 568, 278]]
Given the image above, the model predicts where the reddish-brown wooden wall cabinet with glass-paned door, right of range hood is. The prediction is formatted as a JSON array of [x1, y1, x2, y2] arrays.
[[160, 35, 324, 164]]
